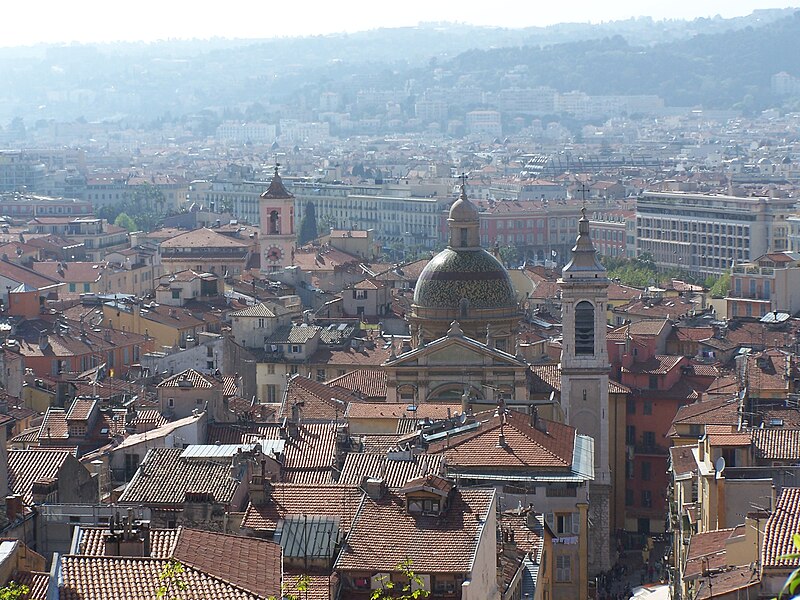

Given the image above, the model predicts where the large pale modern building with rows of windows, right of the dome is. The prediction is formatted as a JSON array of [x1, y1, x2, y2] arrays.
[[636, 192, 796, 275]]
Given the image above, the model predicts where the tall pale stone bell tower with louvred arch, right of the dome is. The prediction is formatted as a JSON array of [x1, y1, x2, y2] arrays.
[[558, 207, 624, 576]]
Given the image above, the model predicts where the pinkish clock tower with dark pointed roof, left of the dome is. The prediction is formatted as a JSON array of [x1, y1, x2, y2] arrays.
[[259, 164, 297, 273]]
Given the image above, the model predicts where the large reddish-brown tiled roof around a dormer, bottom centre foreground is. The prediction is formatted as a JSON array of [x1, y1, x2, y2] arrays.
[[335, 488, 495, 574]]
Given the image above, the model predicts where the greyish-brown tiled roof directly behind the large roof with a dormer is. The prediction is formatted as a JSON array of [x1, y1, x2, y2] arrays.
[[338, 452, 444, 489]]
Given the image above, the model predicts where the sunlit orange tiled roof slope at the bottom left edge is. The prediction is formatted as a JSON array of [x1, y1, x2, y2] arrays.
[[60, 556, 263, 600]]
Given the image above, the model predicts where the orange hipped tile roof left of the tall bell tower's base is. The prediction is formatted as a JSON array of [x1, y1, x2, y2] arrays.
[[428, 411, 575, 469]]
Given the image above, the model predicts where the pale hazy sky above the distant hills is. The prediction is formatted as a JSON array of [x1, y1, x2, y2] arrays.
[[0, 0, 800, 46]]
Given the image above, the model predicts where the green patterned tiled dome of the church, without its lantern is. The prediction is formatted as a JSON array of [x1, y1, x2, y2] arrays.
[[414, 248, 517, 310]]
